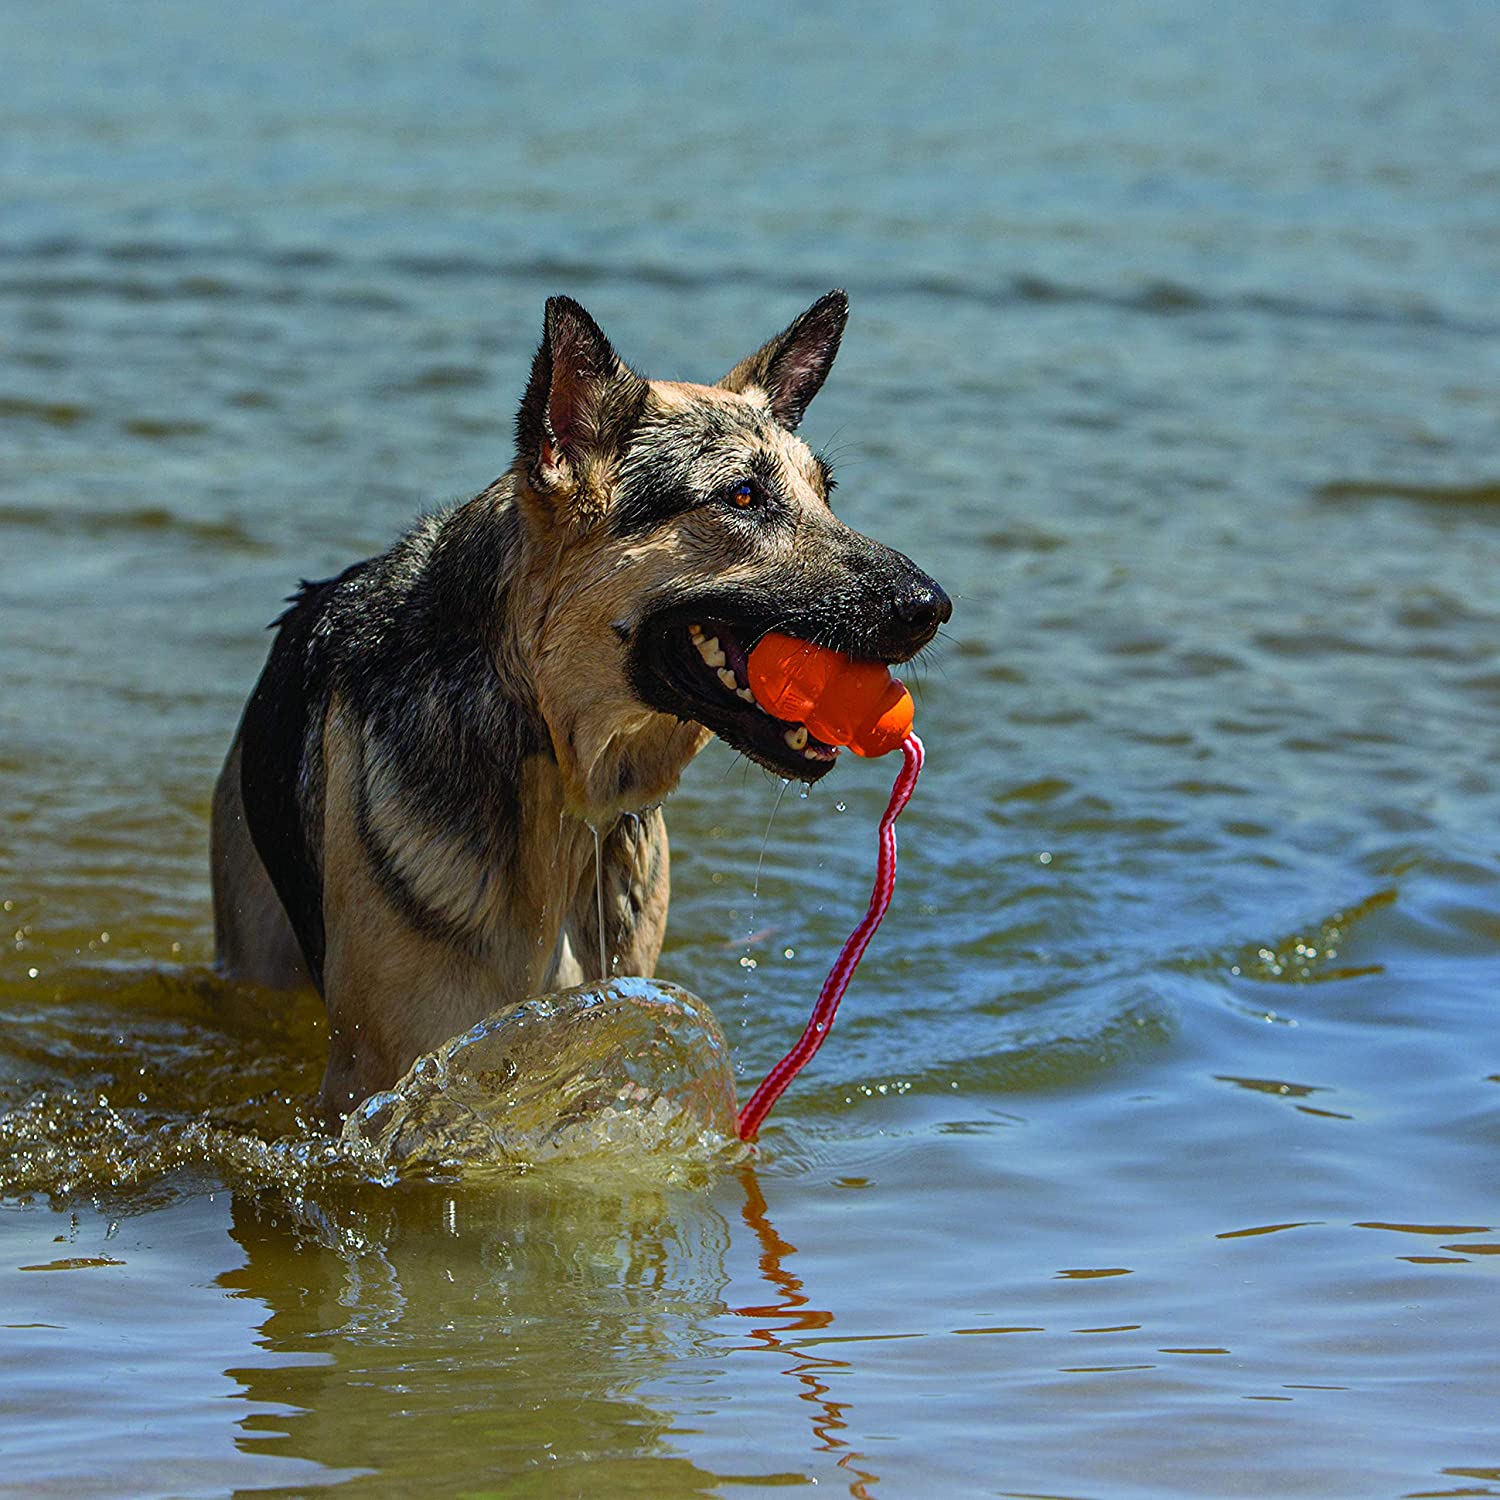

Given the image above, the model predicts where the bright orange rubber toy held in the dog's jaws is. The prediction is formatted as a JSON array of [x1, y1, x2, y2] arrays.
[[750, 632, 914, 756]]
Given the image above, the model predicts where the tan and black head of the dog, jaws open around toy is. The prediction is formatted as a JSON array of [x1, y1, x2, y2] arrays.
[[504, 291, 951, 807]]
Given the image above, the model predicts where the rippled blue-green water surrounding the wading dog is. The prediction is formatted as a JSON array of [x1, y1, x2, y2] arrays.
[[0, 0, 1500, 1500]]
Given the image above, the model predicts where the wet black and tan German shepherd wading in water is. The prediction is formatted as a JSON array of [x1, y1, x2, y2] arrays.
[[212, 291, 951, 1122]]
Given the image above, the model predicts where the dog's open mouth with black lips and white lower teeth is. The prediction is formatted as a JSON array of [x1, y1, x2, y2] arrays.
[[638, 614, 839, 782]]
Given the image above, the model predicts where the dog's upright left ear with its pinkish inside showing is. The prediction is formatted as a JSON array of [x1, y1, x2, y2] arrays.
[[516, 297, 645, 491]]
